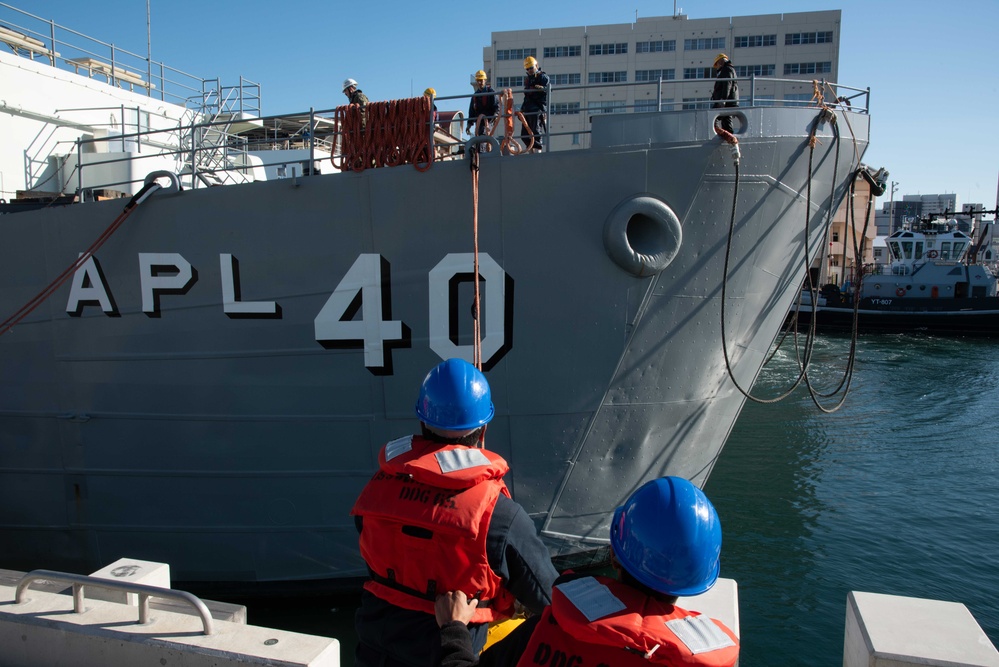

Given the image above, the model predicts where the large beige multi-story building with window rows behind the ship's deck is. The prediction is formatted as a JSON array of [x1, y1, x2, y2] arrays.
[[483, 10, 840, 149]]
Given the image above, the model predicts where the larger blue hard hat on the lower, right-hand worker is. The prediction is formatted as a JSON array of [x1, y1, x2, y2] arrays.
[[611, 477, 721, 596]]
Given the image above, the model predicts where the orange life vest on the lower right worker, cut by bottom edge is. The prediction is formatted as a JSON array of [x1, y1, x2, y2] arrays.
[[517, 577, 739, 667]]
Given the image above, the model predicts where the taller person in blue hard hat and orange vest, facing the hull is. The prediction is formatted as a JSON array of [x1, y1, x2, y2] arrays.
[[351, 359, 558, 667]]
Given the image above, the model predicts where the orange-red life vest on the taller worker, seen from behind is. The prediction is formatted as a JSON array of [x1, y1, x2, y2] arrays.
[[351, 436, 514, 623]]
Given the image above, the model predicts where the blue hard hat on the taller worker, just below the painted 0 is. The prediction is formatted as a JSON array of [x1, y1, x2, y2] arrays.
[[416, 359, 495, 431]]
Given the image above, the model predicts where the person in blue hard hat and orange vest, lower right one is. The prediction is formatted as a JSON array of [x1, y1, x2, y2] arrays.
[[435, 477, 739, 667]]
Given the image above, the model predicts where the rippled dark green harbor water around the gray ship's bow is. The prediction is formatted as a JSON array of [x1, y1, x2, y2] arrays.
[[240, 336, 999, 667]]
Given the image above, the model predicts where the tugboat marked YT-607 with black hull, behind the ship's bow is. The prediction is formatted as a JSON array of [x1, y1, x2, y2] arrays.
[[792, 217, 999, 336]]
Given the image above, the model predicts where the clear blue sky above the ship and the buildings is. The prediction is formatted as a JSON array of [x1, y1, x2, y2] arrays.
[[19, 0, 999, 208]]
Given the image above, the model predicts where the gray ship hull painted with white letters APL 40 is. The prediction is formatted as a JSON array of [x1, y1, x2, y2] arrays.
[[0, 108, 868, 584]]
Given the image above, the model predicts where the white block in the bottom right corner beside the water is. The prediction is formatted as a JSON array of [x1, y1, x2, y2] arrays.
[[843, 591, 999, 667]]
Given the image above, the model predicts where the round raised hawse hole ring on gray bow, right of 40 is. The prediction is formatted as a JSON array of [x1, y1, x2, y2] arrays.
[[604, 195, 683, 278]]
